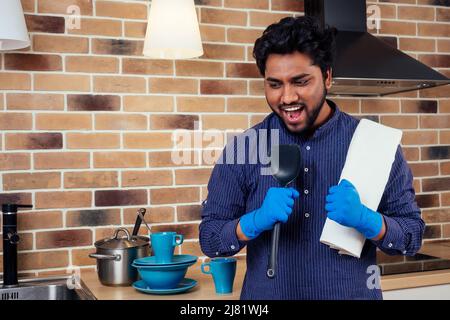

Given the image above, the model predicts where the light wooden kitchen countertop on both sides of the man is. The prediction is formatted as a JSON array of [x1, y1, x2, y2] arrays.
[[81, 260, 450, 300]]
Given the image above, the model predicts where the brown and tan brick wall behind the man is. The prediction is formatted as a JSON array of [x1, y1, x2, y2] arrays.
[[0, 0, 450, 274]]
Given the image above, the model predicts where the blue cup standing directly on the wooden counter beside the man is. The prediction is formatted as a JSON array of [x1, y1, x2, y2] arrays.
[[201, 258, 236, 294]]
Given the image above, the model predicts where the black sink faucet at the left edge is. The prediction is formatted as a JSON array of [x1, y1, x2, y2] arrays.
[[2, 204, 33, 287]]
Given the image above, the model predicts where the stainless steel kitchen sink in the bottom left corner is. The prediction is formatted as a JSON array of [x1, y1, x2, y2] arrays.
[[0, 276, 96, 300]]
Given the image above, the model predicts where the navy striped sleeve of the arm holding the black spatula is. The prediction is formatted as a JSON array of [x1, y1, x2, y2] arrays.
[[199, 140, 247, 257]]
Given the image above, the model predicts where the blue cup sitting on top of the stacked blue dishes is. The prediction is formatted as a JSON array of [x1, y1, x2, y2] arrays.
[[150, 232, 184, 263]]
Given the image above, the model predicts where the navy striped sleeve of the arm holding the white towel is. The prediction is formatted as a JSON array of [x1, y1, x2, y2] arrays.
[[373, 146, 425, 256]]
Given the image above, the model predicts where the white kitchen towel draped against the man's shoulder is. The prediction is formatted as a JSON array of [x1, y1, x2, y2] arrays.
[[320, 119, 402, 258]]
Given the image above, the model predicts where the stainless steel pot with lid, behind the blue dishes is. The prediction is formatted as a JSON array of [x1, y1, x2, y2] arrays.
[[89, 228, 150, 286]]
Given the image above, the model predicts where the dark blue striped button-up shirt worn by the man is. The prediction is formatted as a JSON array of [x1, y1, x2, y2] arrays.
[[199, 100, 424, 299]]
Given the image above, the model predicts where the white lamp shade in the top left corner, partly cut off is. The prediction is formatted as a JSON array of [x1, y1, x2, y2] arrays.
[[0, 0, 30, 50]]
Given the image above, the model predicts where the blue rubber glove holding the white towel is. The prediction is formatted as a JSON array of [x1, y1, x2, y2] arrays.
[[325, 179, 383, 239]]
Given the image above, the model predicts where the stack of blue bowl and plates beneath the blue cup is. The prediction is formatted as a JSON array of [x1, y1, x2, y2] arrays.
[[132, 254, 197, 294]]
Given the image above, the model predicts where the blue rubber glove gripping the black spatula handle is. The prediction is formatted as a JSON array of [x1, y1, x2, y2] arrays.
[[240, 188, 300, 239]]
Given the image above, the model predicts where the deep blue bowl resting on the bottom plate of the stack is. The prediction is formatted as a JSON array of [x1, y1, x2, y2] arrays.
[[132, 261, 195, 289]]
